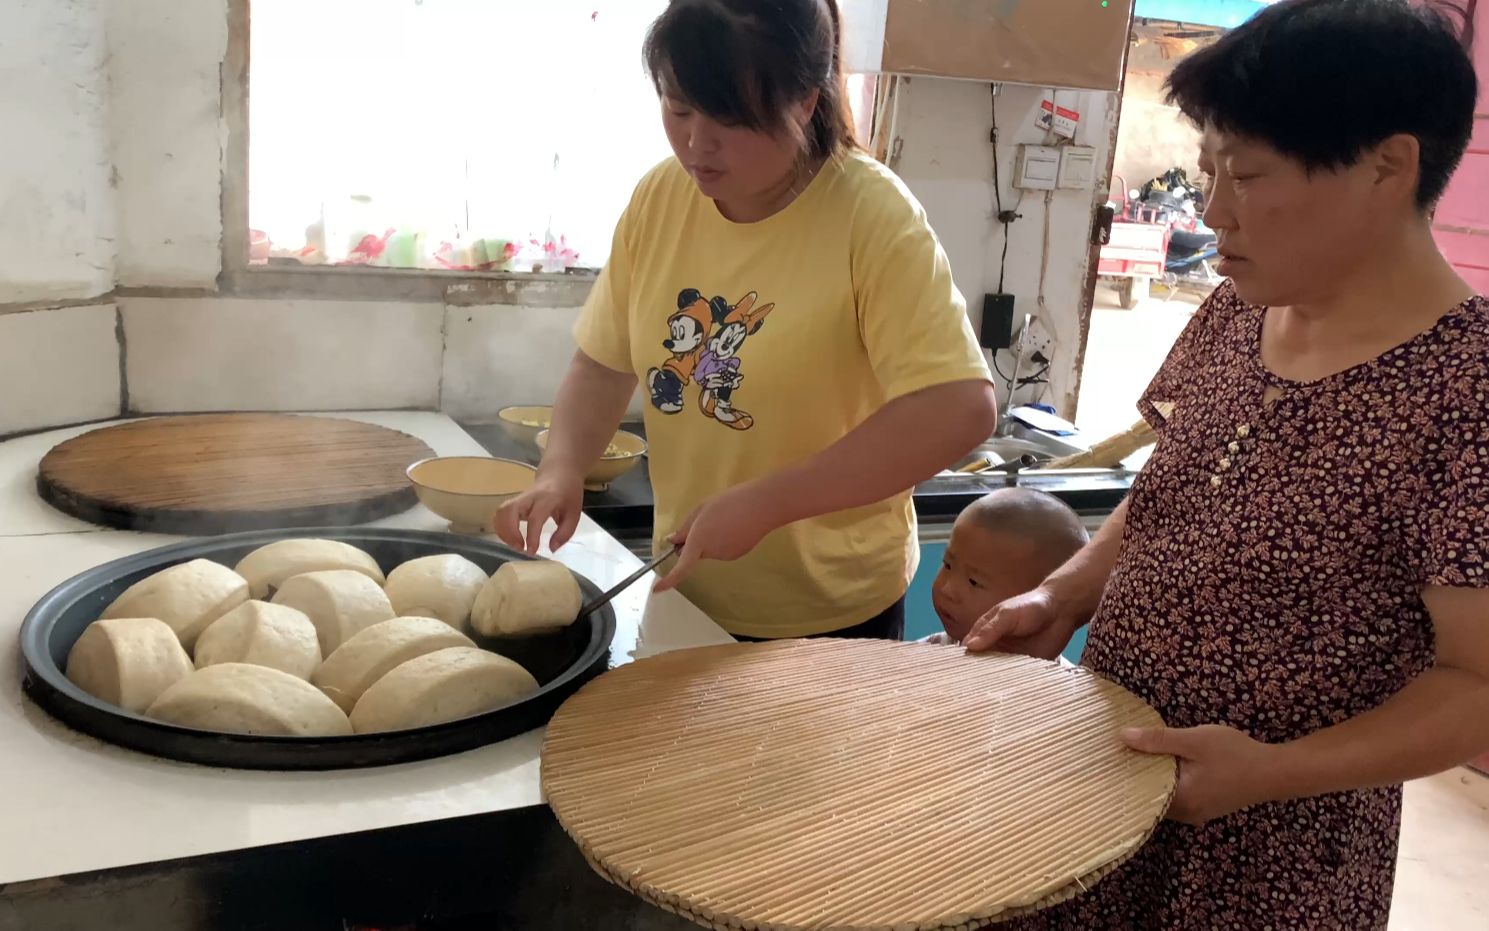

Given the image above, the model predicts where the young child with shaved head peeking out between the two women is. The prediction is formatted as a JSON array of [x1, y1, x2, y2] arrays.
[[926, 489, 1088, 644]]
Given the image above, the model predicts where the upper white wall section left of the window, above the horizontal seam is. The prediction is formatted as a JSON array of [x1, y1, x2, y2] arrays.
[[0, 0, 115, 303]]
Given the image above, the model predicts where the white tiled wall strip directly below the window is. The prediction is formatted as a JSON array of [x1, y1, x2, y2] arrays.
[[107, 298, 613, 420]]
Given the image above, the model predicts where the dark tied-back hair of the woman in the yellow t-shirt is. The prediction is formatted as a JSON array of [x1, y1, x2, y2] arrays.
[[643, 0, 855, 158]]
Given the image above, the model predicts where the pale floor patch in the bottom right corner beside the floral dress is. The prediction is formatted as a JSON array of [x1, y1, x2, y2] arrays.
[[1391, 769, 1489, 931]]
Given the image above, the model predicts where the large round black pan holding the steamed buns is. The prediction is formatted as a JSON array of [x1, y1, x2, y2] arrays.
[[21, 527, 615, 770]]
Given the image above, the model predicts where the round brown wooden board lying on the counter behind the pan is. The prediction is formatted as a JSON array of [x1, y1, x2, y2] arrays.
[[36, 414, 435, 535]]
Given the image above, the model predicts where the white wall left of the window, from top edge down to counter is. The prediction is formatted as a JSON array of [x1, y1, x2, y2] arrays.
[[0, 0, 119, 433]]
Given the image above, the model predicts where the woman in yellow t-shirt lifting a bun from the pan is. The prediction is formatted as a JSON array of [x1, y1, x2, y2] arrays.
[[496, 0, 996, 639]]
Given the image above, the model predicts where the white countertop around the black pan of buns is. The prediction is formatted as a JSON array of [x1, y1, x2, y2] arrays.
[[0, 413, 731, 885]]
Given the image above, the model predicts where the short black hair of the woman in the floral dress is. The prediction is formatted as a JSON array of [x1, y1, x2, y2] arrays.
[[1169, 0, 1479, 210]]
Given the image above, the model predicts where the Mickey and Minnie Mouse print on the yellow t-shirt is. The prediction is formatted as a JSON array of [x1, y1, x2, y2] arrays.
[[646, 287, 776, 430]]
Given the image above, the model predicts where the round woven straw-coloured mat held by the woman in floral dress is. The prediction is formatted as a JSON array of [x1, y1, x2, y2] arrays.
[[542, 641, 1176, 931]]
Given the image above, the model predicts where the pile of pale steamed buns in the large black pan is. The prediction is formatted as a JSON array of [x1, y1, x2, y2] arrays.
[[67, 539, 582, 737]]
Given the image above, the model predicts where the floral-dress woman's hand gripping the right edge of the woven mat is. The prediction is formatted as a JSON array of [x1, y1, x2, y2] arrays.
[[1121, 724, 1281, 827]]
